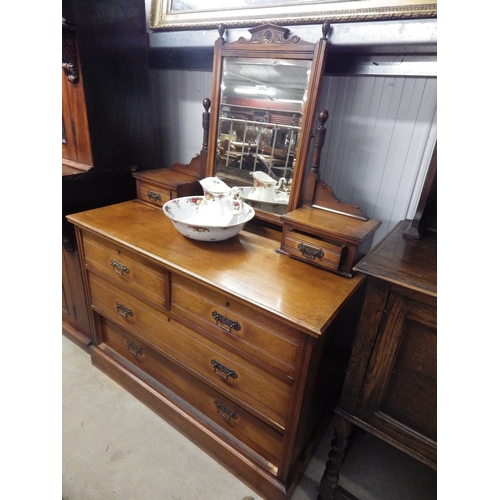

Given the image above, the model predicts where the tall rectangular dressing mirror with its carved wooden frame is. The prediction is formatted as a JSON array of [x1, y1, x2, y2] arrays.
[[207, 23, 329, 224]]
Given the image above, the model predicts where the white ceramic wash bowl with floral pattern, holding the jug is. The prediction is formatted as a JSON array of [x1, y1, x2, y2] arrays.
[[163, 196, 255, 241]]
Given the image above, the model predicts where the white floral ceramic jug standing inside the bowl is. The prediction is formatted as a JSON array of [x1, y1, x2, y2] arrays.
[[198, 177, 242, 226]]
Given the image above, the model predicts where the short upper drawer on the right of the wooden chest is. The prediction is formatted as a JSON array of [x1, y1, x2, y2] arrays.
[[170, 274, 301, 379]]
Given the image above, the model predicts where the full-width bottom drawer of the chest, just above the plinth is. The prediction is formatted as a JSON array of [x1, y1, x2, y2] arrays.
[[99, 317, 283, 468]]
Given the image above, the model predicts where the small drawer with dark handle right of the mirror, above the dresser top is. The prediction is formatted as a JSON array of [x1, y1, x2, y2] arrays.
[[281, 228, 346, 271]]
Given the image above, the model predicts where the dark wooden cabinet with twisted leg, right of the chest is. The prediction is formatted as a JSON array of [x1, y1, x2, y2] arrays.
[[318, 220, 437, 500]]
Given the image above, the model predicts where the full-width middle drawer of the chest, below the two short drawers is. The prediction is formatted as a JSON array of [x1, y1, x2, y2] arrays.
[[89, 274, 291, 432]]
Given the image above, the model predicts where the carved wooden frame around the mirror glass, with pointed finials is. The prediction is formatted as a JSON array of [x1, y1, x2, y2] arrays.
[[207, 21, 330, 226]]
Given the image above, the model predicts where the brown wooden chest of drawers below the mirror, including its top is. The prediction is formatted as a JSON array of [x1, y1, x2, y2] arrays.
[[68, 200, 365, 500]]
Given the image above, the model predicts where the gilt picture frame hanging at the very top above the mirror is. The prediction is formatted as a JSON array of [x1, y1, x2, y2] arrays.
[[149, 0, 437, 31]]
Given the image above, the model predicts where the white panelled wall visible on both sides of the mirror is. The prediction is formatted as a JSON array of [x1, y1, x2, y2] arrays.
[[151, 69, 437, 248]]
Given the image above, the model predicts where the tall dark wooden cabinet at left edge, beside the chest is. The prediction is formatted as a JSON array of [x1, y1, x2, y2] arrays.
[[62, 0, 154, 348]]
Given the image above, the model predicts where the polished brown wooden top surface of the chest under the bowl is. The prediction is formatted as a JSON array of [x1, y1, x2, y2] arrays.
[[67, 200, 365, 337]]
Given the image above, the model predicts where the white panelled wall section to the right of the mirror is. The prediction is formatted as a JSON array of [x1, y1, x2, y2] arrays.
[[319, 76, 437, 242]]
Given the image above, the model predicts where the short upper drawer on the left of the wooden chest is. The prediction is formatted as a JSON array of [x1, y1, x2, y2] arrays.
[[83, 233, 167, 307]]
